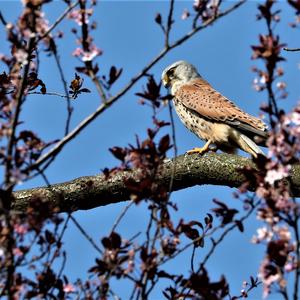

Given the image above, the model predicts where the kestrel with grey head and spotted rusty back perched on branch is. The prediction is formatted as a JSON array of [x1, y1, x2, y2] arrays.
[[161, 60, 268, 158]]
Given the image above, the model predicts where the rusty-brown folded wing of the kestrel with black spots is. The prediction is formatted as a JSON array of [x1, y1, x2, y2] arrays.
[[175, 78, 268, 138]]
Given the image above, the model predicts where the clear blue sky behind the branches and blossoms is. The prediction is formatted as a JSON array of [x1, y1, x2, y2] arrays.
[[0, 1, 300, 299]]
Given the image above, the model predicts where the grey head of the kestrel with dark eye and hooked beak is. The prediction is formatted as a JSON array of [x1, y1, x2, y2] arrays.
[[161, 60, 200, 89]]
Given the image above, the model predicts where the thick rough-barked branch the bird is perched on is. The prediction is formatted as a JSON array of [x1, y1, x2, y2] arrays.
[[12, 153, 300, 212]]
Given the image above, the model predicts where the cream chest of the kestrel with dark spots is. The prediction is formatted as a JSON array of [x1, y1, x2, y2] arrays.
[[173, 98, 212, 140]]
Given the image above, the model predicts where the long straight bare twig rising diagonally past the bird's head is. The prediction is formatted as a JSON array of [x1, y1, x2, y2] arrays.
[[26, 0, 245, 169]]
